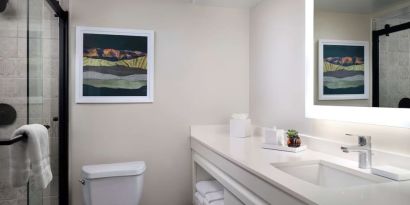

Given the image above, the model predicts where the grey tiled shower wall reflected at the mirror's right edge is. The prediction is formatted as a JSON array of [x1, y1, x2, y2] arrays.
[[377, 19, 410, 108]]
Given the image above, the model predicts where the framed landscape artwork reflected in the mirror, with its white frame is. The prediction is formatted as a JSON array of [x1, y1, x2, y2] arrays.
[[318, 40, 369, 100]]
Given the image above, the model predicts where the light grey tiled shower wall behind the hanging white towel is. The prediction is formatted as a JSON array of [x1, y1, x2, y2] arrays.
[[0, 0, 59, 205]]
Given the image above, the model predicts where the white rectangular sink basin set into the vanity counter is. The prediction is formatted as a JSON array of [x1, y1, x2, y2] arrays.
[[272, 160, 390, 188]]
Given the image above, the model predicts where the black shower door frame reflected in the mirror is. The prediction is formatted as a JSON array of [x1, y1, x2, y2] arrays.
[[372, 22, 410, 107]]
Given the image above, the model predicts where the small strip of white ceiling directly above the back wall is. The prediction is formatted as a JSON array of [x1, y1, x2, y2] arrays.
[[192, 0, 262, 8]]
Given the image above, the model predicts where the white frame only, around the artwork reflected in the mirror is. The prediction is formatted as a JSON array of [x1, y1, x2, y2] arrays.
[[318, 39, 370, 100]]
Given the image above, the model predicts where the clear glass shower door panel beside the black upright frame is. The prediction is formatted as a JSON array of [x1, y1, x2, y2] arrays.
[[27, 0, 59, 205]]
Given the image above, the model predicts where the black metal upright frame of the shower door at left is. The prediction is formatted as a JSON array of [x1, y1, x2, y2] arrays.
[[27, 0, 69, 205]]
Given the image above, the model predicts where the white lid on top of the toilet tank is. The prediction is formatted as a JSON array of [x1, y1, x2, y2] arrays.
[[82, 161, 146, 179]]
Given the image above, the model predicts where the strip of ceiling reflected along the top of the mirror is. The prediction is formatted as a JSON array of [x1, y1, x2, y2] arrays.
[[315, 0, 410, 14]]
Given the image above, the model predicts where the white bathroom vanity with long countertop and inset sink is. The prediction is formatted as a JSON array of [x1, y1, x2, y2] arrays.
[[191, 126, 410, 205]]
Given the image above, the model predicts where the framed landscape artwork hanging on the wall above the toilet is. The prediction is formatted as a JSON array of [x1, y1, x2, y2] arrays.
[[75, 27, 154, 103]]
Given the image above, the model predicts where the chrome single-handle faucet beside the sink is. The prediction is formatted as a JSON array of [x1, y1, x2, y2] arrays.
[[341, 134, 372, 169]]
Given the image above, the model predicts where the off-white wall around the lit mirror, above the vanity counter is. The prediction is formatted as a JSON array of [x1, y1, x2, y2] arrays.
[[250, 0, 410, 156]]
